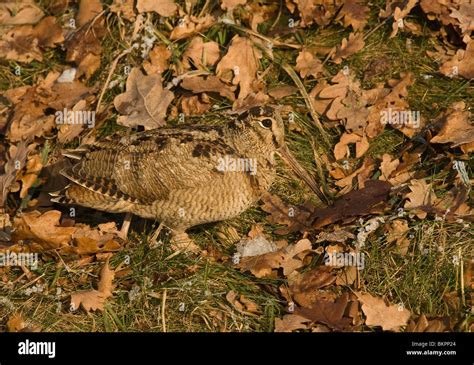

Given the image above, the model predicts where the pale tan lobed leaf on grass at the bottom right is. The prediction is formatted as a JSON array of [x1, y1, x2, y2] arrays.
[[355, 292, 411, 332]]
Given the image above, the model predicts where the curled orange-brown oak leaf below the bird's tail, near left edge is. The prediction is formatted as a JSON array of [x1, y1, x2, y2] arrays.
[[12, 210, 77, 250]]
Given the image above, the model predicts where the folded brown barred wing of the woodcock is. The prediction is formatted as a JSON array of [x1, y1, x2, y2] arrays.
[[63, 127, 253, 204]]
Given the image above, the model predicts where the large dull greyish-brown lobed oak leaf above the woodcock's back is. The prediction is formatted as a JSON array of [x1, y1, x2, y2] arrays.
[[114, 67, 174, 129]]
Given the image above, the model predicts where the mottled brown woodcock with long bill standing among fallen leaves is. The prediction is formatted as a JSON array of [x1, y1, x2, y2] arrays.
[[53, 106, 326, 250]]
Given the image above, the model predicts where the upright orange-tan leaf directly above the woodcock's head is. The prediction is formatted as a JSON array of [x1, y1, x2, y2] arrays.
[[216, 35, 262, 99]]
